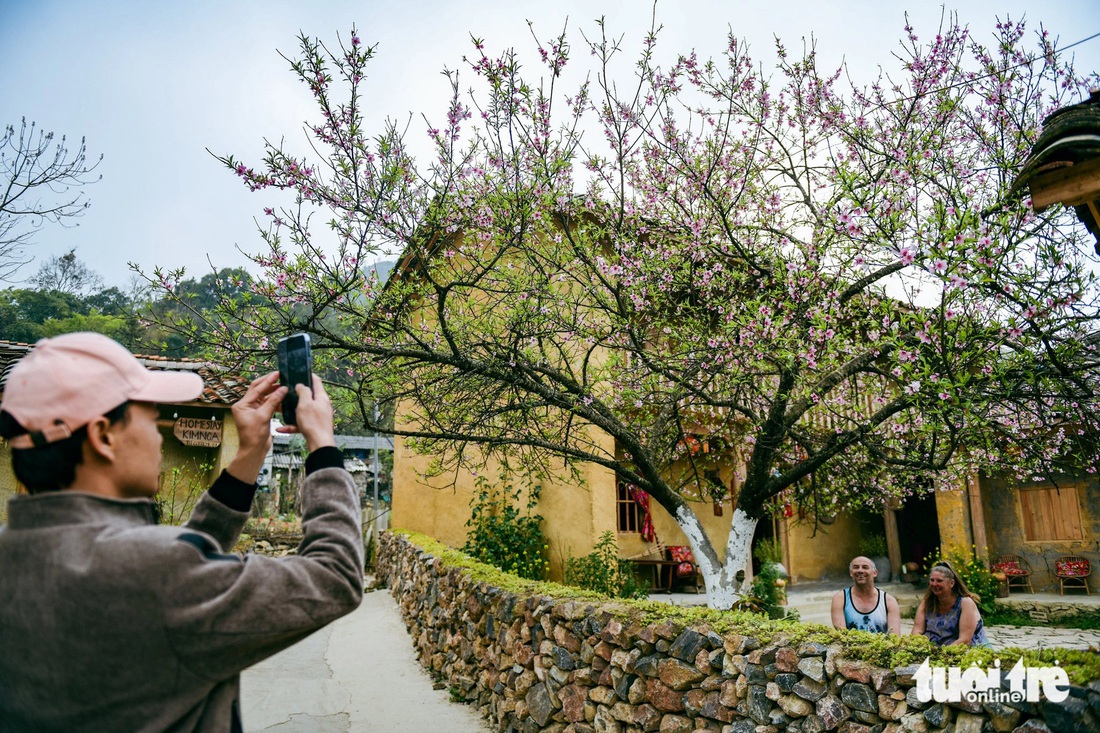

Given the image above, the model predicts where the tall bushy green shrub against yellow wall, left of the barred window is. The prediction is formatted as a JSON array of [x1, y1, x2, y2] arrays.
[[462, 474, 549, 580]]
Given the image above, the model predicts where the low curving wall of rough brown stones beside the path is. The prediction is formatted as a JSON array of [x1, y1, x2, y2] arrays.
[[377, 533, 1100, 733]]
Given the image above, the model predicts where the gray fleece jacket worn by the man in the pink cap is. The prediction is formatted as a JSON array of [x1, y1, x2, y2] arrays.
[[0, 449, 363, 733]]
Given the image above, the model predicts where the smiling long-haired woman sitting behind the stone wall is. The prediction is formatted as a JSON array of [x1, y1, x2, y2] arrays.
[[913, 561, 988, 646]]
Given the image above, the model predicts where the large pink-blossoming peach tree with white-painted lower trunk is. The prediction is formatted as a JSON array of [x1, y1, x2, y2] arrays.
[[150, 19, 1100, 608]]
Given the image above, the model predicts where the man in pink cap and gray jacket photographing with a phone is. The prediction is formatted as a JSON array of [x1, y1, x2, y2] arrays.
[[0, 333, 363, 732]]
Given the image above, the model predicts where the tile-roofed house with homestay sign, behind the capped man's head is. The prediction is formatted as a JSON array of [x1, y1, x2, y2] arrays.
[[0, 341, 249, 523]]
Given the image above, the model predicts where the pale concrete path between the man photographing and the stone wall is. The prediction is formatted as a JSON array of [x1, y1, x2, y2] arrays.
[[241, 591, 492, 733]]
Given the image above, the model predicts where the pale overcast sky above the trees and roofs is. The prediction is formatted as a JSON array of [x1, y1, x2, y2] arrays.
[[0, 0, 1100, 286]]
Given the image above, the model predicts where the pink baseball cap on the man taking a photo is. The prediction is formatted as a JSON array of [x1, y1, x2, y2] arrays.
[[0, 332, 202, 448]]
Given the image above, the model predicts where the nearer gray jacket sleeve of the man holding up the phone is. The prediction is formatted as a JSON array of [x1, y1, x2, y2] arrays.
[[160, 468, 363, 680]]
